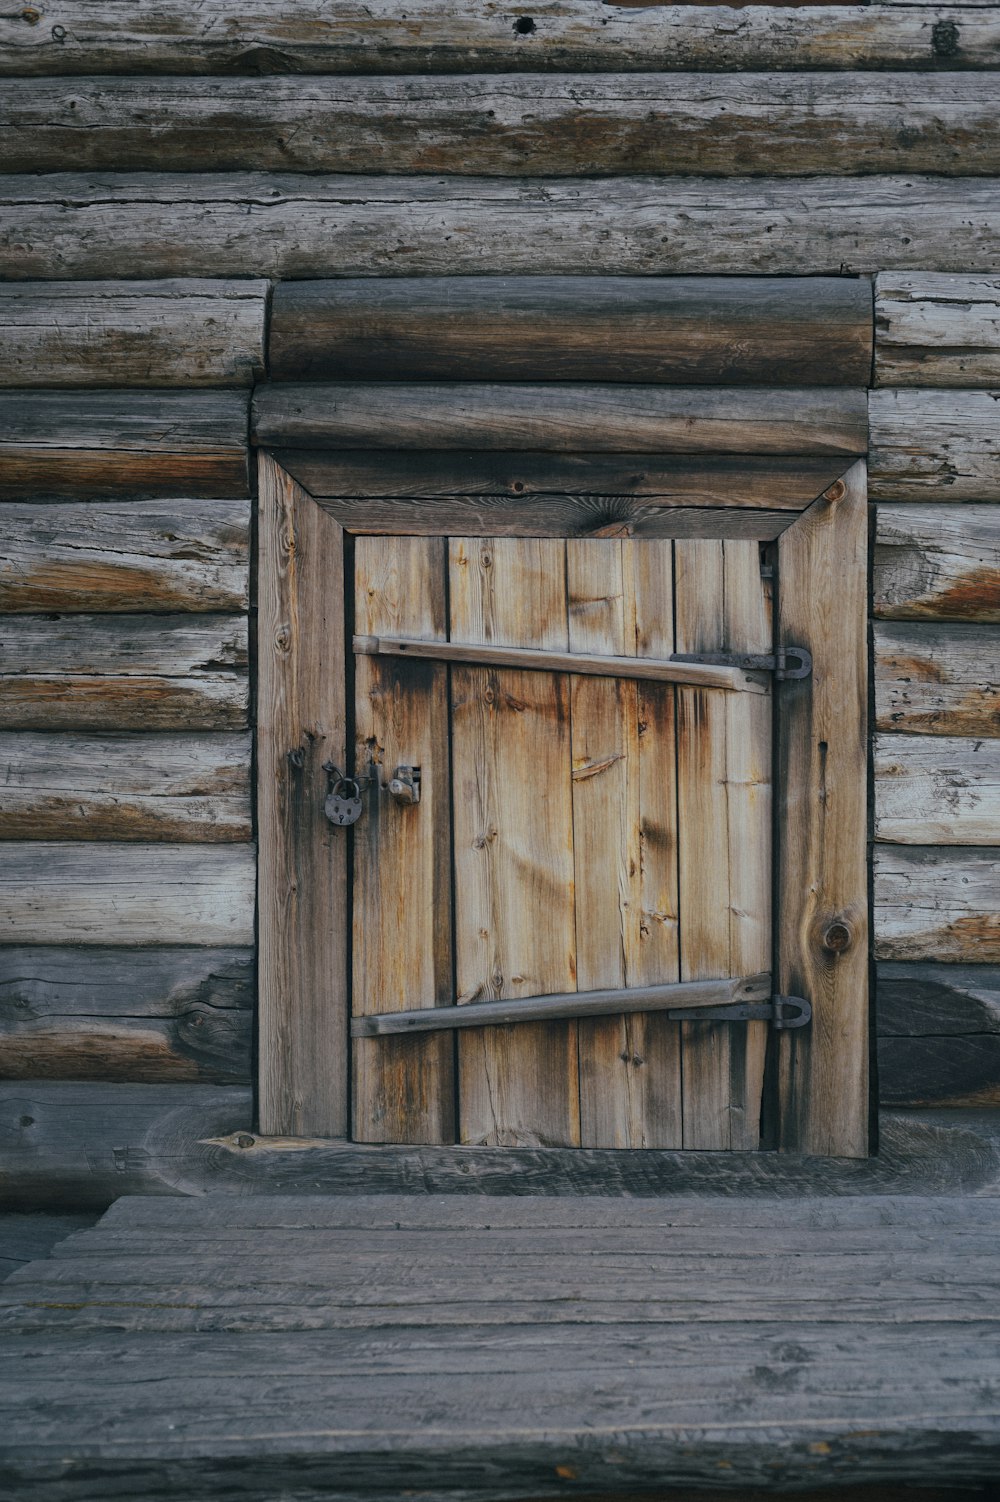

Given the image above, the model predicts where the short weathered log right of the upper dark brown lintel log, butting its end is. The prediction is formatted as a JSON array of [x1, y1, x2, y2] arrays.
[[875, 272, 1000, 386]]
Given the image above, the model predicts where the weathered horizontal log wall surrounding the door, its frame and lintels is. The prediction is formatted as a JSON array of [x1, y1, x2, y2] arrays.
[[0, 0, 1000, 1202]]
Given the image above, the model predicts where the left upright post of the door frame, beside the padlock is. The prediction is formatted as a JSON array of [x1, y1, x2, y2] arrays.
[[257, 454, 347, 1137]]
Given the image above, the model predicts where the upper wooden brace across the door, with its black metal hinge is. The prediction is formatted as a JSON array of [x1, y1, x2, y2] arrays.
[[354, 635, 812, 694]]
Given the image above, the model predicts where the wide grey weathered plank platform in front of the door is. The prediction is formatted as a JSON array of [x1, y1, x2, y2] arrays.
[[0, 1194, 1000, 1502]]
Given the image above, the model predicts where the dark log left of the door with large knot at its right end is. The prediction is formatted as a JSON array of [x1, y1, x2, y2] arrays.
[[0, 946, 254, 1084]]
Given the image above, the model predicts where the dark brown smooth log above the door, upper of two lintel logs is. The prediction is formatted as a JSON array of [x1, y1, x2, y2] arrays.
[[267, 276, 872, 386]]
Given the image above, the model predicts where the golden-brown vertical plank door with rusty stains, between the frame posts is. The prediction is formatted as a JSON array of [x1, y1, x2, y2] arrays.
[[347, 535, 773, 1149]]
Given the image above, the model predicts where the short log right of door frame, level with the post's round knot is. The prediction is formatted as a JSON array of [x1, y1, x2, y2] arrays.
[[874, 846, 1000, 964]]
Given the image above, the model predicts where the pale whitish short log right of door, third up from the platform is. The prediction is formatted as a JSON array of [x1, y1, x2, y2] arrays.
[[875, 736, 1000, 846]]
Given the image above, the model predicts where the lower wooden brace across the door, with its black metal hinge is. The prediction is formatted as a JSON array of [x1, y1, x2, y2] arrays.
[[351, 973, 812, 1038]]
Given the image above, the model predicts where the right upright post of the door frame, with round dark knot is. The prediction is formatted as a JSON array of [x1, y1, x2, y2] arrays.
[[778, 463, 869, 1158]]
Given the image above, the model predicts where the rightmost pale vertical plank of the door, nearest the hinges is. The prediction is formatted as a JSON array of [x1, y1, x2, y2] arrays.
[[674, 541, 770, 1151]]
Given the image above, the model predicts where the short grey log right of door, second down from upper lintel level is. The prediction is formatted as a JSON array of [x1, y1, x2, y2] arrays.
[[868, 391, 1000, 500]]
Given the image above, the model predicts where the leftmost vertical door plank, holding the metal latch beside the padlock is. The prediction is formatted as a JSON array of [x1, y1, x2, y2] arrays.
[[351, 538, 455, 1143]]
